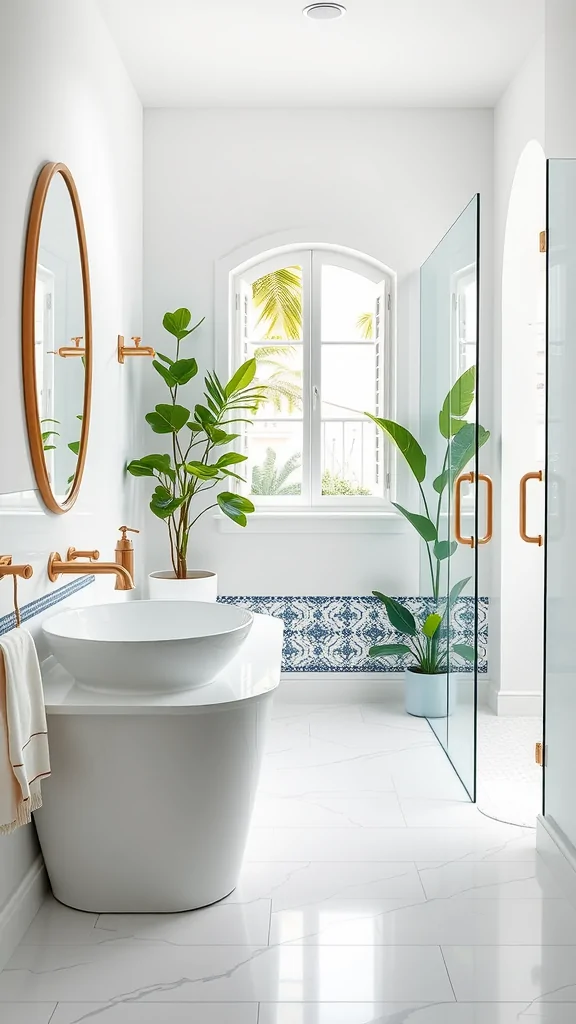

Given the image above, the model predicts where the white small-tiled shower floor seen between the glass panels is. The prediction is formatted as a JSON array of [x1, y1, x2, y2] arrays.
[[478, 709, 542, 827]]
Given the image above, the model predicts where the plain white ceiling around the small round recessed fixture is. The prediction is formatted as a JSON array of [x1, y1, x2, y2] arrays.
[[98, 0, 543, 106]]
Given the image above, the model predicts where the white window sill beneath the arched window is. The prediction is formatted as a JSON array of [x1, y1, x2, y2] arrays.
[[214, 509, 410, 534]]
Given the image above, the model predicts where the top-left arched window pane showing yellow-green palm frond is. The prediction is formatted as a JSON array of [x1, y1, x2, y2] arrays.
[[243, 265, 302, 341]]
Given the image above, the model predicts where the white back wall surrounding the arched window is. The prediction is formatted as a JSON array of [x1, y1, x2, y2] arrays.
[[142, 110, 492, 595]]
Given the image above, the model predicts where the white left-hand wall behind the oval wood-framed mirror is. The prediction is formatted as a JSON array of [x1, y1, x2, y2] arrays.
[[0, 0, 141, 954]]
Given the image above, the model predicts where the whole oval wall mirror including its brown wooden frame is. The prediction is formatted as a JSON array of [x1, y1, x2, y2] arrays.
[[23, 164, 92, 513]]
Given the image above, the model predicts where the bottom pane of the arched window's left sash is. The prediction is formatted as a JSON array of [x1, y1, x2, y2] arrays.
[[245, 420, 302, 497]]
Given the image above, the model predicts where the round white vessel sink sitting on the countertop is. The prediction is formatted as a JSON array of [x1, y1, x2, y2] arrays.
[[43, 601, 254, 693]]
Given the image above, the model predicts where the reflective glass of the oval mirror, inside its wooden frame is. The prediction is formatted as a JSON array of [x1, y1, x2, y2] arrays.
[[34, 174, 85, 500]]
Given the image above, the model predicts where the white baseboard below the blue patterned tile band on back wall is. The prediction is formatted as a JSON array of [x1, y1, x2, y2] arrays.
[[277, 672, 488, 703]]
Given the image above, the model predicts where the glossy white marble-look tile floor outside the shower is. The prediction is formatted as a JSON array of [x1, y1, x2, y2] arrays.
[[0, 705, 576, 1024]]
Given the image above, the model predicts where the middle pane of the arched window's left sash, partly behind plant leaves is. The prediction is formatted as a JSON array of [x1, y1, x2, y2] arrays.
[[246, 342, 302, 420]]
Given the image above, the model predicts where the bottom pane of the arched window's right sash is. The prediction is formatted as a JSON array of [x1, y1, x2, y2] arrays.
[[322, 420, 382, 495]]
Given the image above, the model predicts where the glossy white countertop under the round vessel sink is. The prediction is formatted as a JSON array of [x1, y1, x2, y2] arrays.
[[42, 614, 284, 715]]
